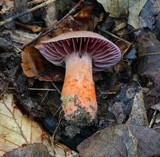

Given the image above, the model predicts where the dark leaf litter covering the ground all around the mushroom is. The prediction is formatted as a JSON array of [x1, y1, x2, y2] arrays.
[[0, 0, 160, 157]]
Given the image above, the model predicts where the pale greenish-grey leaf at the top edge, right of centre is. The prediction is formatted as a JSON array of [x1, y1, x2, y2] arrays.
[[98, 0, 147, 28]]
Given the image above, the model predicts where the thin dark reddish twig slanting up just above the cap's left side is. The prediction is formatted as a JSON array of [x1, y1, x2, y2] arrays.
[[22, 0, 84, 49]]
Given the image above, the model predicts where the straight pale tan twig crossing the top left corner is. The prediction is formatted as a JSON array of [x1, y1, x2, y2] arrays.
[[0, 0, 55, 26]]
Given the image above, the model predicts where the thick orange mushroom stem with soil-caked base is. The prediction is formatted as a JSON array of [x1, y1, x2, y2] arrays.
[[61, 53, 97, 124]]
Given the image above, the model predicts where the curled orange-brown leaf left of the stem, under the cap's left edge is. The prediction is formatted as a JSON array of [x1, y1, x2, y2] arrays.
[[21, 46, 64, 81]]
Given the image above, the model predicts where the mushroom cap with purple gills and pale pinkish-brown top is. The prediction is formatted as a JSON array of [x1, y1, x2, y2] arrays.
[[39, 31, 121, 71]]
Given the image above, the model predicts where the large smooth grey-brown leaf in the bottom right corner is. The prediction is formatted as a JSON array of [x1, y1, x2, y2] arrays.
[[77, 125, 160, 157]]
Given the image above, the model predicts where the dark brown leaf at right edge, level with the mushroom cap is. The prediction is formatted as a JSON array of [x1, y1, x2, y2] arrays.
[[137, 32, 160, 84]]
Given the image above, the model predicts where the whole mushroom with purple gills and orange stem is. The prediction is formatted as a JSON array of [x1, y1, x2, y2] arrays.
[[39, 31, 121, 125]]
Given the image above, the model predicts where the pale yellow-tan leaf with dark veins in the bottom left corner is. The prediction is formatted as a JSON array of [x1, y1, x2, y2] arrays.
[[0, 94, 76, 157]]
